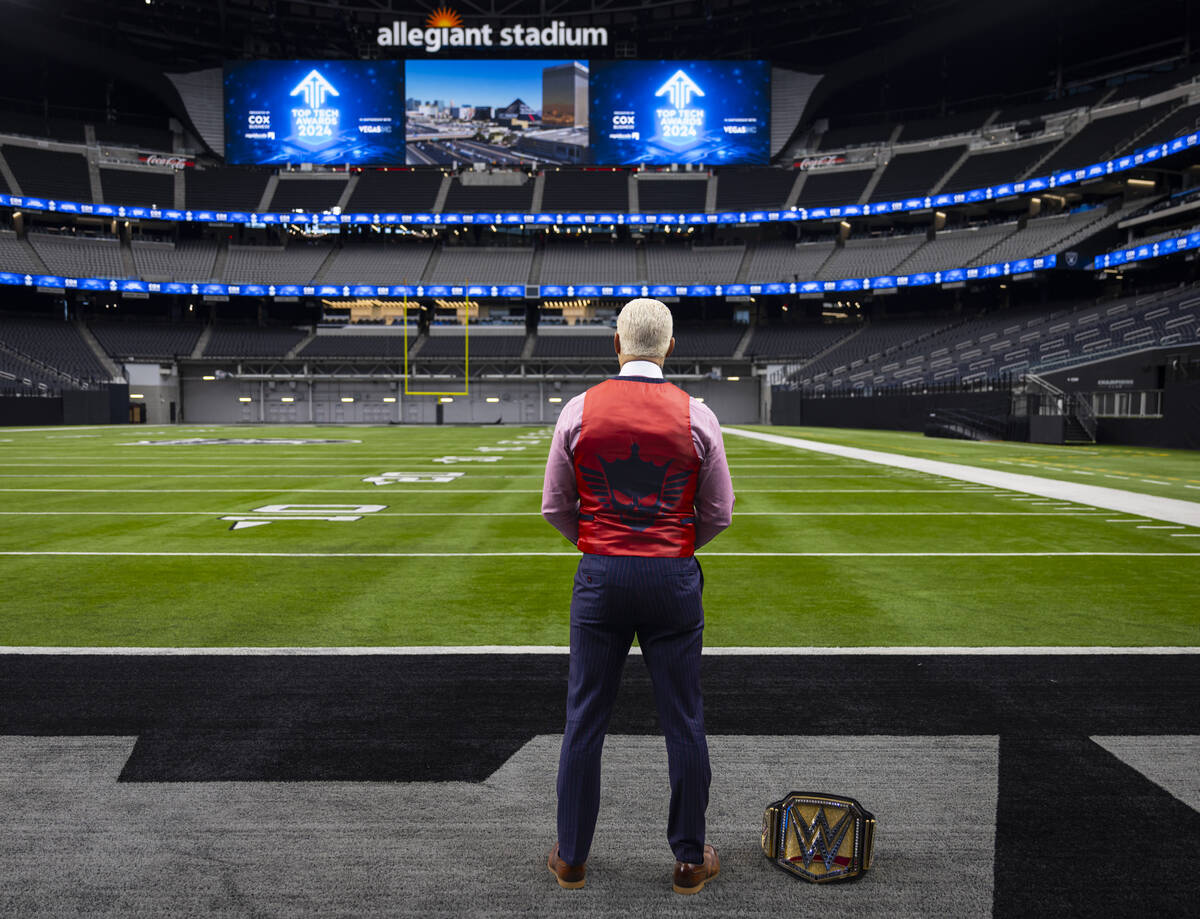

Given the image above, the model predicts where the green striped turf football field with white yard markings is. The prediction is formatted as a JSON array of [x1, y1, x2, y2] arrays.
[[0, 426, 1200, 647]]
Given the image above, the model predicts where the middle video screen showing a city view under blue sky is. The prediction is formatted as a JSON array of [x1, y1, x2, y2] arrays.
[[404, 60, 588, 166]]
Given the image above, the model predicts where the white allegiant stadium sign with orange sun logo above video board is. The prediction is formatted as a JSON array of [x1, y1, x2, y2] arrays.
[[376, 8, 608, 54]]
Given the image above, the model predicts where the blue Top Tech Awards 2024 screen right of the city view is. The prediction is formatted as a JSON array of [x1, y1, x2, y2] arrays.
[[590, 61, 770, 166]]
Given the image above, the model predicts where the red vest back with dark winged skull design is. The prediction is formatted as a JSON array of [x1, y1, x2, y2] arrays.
[[575, 377, 700, 558]]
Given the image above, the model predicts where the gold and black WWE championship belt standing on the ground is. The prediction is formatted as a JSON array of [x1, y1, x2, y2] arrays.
[[762, 792, 875, 884]]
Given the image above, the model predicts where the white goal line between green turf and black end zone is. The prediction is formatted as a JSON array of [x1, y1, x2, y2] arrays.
[[0, 644, 1200, 657]]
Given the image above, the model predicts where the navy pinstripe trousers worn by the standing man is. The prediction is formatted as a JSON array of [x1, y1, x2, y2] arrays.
[[558, 554, 712, 865]]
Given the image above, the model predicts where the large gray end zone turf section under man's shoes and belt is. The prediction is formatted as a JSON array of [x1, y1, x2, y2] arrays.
[[0, 735, 997, 919]]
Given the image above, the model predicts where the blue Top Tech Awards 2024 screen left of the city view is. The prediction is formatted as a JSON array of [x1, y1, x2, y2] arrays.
[[224, 60, 404, 166]]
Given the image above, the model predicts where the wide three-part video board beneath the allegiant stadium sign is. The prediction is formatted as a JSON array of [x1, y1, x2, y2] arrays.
[[224, 59, 770, 166]]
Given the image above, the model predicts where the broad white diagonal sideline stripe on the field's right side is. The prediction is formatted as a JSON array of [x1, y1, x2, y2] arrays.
[[721, 426, 1200, 527]]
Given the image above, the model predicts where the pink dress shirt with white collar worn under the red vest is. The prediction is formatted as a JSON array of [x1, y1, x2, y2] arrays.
[[541, 361, 733, 548]]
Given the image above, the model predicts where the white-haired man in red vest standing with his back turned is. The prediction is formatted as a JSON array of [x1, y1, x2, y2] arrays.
[[541, 299, 733, 894]]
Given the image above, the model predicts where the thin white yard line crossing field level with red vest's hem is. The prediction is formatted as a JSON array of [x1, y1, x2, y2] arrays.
[[0, 551, 1200, 559]]
